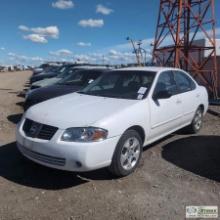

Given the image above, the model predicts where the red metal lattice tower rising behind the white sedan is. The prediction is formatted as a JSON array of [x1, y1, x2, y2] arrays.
[[153, 0, 219, 98]]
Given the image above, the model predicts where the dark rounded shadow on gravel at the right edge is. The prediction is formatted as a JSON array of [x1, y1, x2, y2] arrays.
[[162, 136, 220, 182]]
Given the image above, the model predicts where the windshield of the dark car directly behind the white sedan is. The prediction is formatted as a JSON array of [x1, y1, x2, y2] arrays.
[[57, 70, 104, 86]]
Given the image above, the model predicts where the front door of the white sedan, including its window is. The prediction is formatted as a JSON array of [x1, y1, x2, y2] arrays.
[[149, 71, 183, 140]]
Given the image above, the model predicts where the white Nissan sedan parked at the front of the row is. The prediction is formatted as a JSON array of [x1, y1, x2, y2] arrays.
[[16, 67, 208, 176]]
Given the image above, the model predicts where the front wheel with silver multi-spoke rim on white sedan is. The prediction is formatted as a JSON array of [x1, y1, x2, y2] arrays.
[[109, 130, 143, 177]]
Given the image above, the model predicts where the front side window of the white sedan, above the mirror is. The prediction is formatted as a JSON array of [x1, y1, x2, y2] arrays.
[[154, 71, 177, 95]]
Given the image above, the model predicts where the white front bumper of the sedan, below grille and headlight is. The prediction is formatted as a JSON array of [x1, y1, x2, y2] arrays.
[[16, 124, 120, 172]]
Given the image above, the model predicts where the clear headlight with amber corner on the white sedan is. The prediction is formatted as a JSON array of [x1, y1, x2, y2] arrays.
[[61, 127, 108, 142]]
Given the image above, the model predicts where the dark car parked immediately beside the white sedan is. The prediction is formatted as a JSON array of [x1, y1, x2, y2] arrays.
[[24, 68, 109, 110]]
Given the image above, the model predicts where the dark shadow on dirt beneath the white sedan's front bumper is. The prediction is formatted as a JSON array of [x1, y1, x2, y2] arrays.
[[0, 142, 114, 190]]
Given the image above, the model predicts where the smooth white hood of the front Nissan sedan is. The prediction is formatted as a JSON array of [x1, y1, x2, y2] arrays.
[[25, 93, 138, 129]]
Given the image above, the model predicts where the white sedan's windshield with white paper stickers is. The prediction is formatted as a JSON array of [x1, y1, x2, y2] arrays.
[[79, 71, 156, 100]]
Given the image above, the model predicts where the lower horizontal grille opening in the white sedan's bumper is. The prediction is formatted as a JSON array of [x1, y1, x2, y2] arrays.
[[19, 145, 66, 166]]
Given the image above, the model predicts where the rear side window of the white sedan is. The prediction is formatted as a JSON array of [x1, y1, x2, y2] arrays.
[[174, 71, 196, 93]]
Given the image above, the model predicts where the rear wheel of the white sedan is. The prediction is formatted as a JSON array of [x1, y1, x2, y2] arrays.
[[187, 107, 203, 134]]
